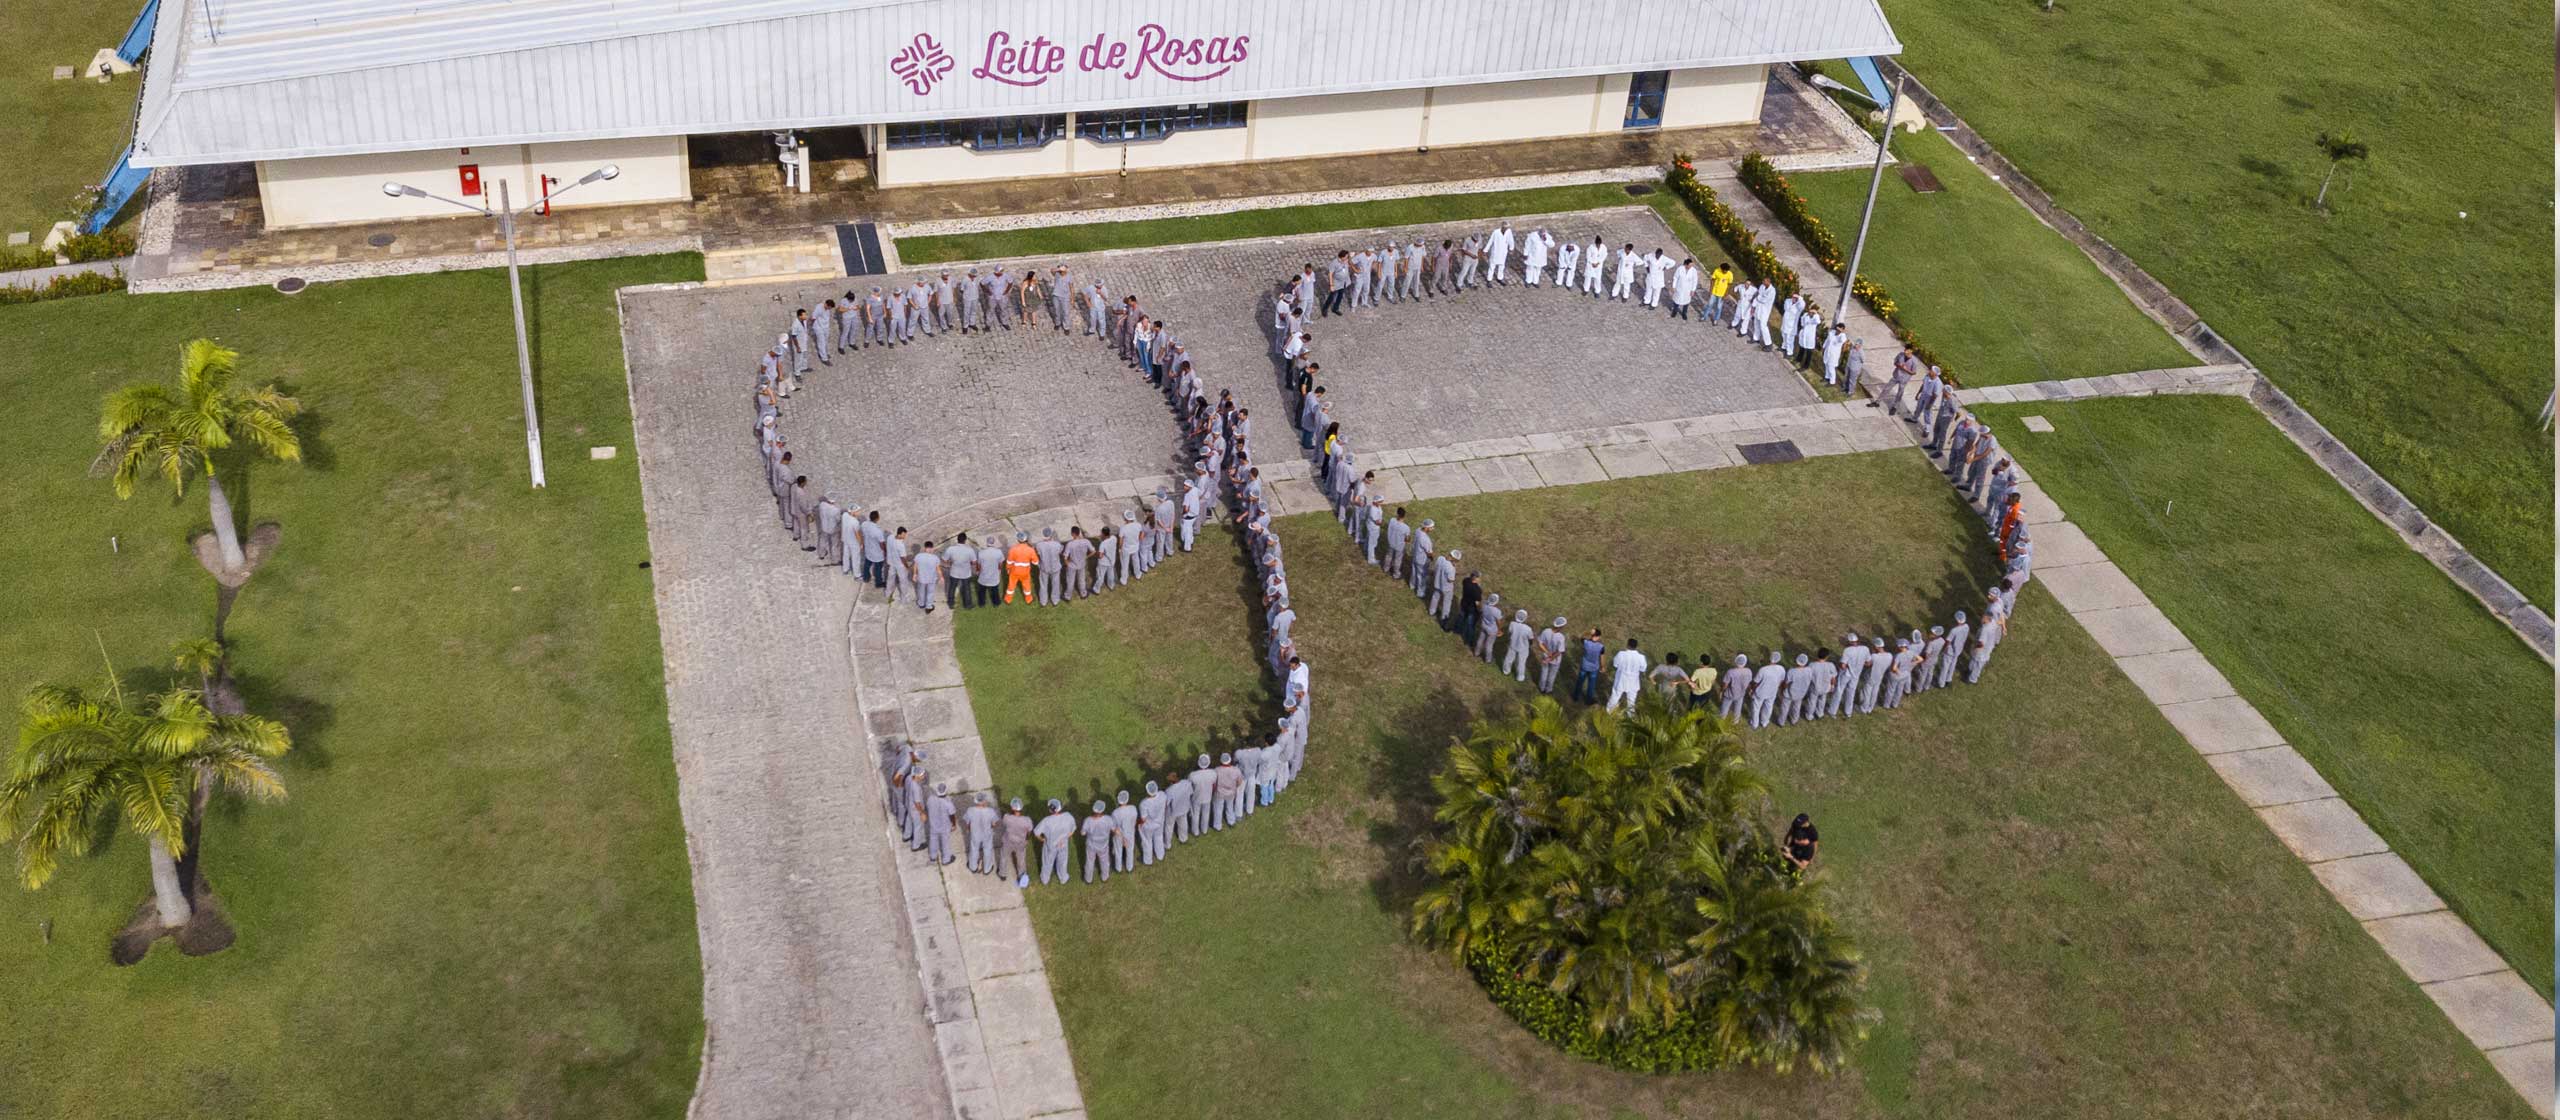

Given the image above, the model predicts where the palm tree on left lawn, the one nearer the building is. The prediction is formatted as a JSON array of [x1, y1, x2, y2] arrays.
[[97, 338, 302, 586]]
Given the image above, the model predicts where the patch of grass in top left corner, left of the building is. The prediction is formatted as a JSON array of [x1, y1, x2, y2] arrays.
[[0, 0, 143, 243]]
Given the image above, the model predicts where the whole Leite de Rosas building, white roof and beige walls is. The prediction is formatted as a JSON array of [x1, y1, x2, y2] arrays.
[[131, 0, 1900, 228]]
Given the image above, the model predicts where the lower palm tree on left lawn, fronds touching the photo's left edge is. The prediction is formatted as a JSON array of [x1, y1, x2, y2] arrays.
[[0, 667, 292, 928]]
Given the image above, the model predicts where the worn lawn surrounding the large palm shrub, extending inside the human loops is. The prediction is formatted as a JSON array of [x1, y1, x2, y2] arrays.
[[960, 453, 2524, 1120]]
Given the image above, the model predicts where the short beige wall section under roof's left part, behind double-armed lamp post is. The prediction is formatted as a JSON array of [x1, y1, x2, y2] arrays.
[[259, 136, 694, 230]]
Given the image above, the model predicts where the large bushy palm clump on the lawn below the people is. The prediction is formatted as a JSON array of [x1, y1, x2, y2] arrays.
[[1413, 696, 1874, 1071]]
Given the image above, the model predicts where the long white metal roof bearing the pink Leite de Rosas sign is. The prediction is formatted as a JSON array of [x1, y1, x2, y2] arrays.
[[133, 0, 1902, 166]]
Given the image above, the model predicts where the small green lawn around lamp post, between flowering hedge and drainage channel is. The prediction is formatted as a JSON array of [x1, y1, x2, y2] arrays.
[[1781, 120, 2196, 386]]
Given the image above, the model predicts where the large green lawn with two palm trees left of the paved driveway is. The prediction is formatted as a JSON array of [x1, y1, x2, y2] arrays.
[[0, 256, 701, 1117]]
